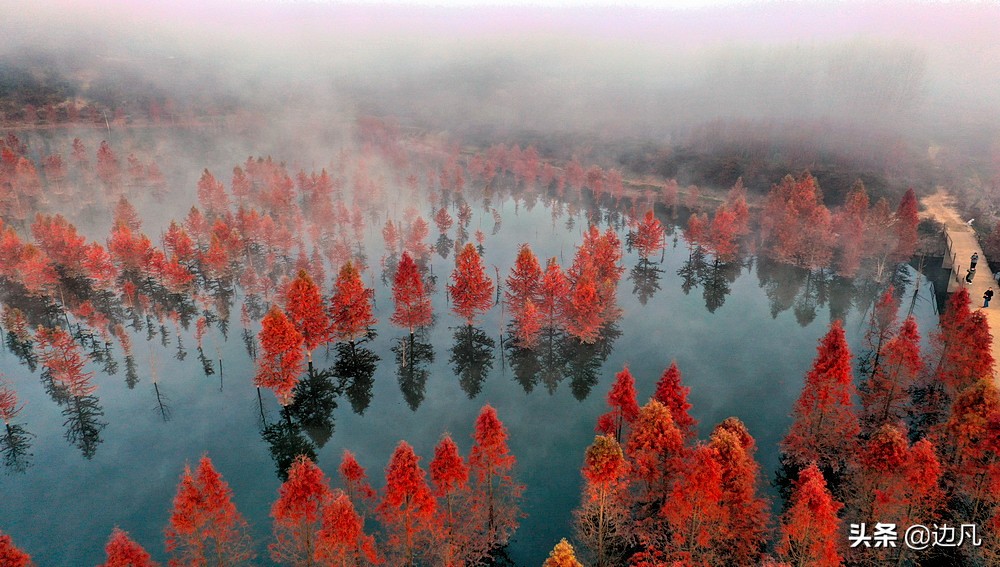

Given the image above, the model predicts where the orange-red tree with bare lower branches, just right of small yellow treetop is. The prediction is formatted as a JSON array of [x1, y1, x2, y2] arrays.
[[573, 435, 629, 567]]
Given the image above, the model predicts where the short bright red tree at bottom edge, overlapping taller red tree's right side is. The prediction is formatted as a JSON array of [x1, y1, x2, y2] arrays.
[[316, 490, 382, 567]]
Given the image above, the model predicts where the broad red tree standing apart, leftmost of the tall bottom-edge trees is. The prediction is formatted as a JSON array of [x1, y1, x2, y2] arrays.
[[166, 456, 255, 567]]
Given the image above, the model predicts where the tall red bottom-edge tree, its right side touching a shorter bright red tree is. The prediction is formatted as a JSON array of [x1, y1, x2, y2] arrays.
[[268, 455, 333, 565]]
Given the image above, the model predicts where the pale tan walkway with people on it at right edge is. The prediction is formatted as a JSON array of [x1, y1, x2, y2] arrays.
[[921, 189, 1000, 374]]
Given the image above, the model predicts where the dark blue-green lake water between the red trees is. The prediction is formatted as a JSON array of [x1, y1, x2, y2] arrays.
[[0, 184, 936, 566]]
